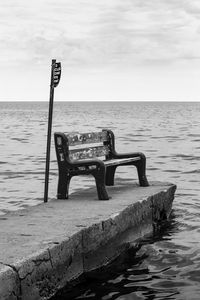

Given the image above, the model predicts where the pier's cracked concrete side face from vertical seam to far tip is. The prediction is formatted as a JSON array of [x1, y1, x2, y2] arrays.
[[83, 185, 176, 272]]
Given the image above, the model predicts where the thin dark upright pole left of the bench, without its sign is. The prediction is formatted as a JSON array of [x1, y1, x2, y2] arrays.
[[44, 59, 56, 202]]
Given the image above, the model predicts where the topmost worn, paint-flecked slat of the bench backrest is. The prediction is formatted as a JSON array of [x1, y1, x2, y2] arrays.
[[66, 131, 107, 146]]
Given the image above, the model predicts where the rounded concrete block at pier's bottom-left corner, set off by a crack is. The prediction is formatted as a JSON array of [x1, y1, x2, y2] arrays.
[[0, 264, 20, 300]]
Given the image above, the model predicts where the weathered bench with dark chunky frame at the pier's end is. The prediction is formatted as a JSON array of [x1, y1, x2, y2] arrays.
[[54, 129, 149, 200]]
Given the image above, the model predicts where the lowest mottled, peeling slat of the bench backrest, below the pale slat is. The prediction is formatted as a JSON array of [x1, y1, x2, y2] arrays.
[[69, 146, 109, 160]]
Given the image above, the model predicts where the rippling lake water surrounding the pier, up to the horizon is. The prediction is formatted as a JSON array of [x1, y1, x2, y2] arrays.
[[0, 102, 200, 300]]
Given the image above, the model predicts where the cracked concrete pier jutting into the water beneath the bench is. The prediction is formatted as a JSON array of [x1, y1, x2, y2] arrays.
[[0, 182, 176, 300]]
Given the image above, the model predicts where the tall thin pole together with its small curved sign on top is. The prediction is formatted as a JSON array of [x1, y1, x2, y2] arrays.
[[44, 59, 61, 202]]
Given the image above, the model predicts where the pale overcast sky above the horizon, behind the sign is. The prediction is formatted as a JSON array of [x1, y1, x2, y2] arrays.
[[0, 0, 200, 101]]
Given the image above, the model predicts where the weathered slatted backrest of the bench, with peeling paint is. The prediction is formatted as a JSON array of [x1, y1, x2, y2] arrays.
[[55, 130, 110, 161]]
